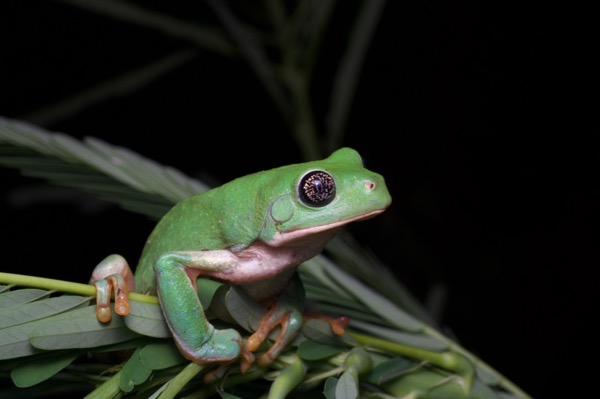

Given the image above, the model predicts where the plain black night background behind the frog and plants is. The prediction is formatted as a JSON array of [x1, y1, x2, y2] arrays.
[[0, 1, 598, 398]]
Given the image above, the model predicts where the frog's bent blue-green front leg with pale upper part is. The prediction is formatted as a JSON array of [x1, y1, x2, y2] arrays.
[[154, 251, 254, 364]]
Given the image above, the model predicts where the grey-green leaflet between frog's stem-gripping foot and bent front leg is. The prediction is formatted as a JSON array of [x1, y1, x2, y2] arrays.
[[125, 301, 172, 338]]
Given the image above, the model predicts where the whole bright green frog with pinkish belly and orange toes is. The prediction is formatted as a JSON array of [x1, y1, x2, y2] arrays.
[[92, 148, 391, 365]]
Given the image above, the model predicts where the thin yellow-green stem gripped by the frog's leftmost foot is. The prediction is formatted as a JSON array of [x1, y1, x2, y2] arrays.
[[0, 272, 158, 304]]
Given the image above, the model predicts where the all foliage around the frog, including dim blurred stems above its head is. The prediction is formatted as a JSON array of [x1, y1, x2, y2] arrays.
[[0, 0, 528, 399]]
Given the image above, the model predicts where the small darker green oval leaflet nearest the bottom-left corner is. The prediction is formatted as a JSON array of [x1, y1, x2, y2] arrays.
[[10, 352, 80, 388]]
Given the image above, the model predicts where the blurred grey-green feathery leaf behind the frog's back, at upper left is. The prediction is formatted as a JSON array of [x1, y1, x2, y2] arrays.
[[0, 117, 208, 219]]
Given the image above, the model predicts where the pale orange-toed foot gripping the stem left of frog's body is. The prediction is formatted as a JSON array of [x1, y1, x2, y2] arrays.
[[90, 255, 135, 322]]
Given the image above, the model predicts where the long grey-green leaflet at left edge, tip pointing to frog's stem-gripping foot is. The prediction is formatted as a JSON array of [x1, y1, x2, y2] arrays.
[[0, 295, 89, 329]]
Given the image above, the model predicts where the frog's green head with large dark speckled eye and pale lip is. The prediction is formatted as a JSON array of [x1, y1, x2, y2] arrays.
[[260, 148, 392, 246]]
